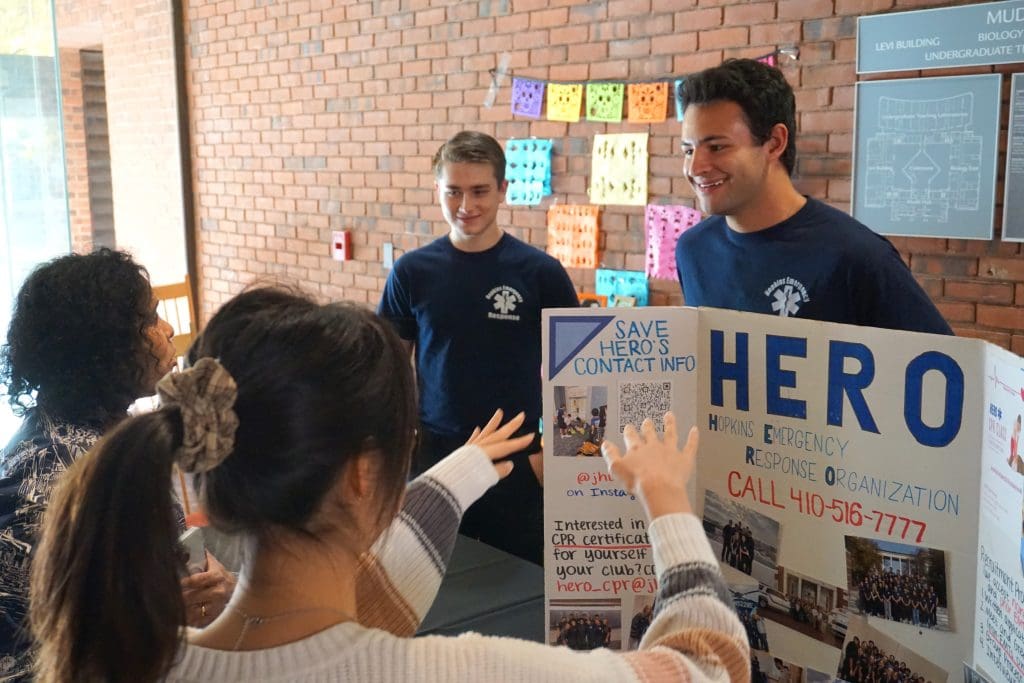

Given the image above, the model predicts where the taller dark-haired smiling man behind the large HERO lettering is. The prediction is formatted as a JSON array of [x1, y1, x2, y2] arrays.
[[676, 59, 952, 334]]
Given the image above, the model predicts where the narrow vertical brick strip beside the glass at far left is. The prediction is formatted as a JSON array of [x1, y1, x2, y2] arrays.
[[60, 49, 92, 254]]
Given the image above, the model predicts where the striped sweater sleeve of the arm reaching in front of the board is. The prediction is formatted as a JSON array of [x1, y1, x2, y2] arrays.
[[626, 514, 751, 682]]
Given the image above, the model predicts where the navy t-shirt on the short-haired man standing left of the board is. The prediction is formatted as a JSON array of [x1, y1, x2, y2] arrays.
[[377, 233, 580, 436]]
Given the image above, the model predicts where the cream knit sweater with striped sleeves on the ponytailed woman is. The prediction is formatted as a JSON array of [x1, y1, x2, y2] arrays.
[[166, 449, 750, 683]]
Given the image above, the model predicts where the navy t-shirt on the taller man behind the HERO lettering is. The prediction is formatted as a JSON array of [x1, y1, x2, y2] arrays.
[[676, 198, 952, 335]]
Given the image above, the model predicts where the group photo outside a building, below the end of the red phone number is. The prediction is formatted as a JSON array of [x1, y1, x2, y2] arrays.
[[846, 536, 952, 631]]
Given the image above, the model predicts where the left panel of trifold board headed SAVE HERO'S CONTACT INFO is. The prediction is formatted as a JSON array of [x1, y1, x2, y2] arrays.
[[544, 308, 697, 649]]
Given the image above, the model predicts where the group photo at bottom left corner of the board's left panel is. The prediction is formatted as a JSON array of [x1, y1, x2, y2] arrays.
[[548, 599, 623, 650]]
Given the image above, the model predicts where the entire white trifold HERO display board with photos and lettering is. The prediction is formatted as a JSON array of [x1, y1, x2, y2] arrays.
[[544, 307, 1024, 683]]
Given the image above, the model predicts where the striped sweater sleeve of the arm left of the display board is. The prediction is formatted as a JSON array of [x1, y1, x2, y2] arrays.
[[356, 445, 498, 636]]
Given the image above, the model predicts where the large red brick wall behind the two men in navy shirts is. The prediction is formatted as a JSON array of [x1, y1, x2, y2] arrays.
[[185, 0, 1024, 353]]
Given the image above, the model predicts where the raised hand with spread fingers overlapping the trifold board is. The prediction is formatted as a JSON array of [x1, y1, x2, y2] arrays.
[[601, 412, 698, 519]]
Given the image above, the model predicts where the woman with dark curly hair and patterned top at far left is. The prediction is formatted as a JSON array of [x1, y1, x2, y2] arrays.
[[0, 249, 227, 681]]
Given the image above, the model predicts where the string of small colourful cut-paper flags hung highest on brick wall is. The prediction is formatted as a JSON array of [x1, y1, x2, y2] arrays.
[[490, 47, 800, 123]]
